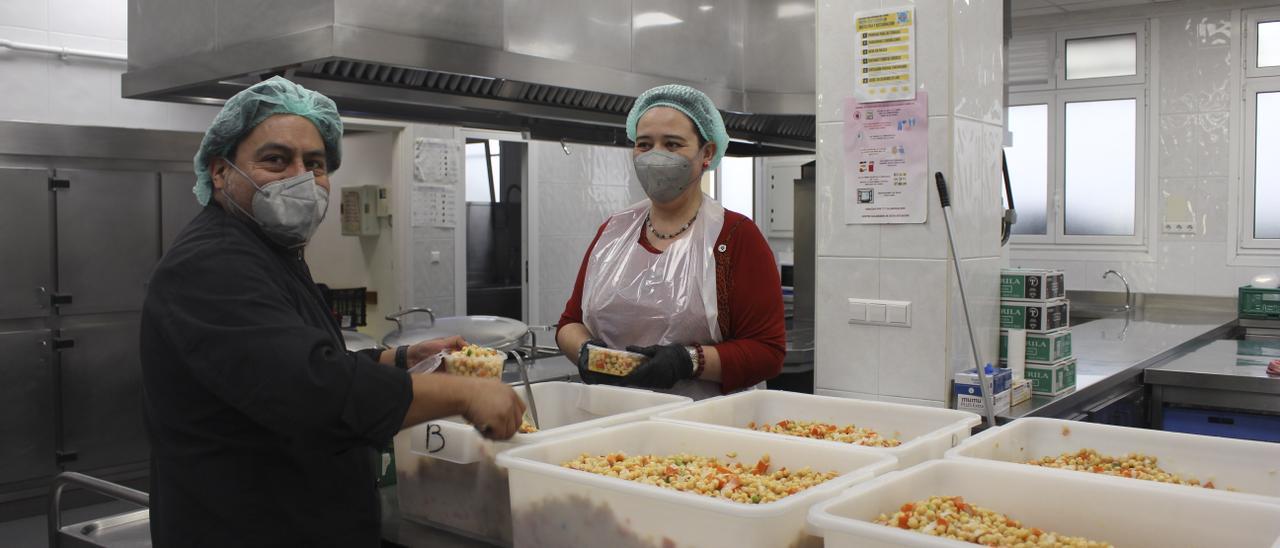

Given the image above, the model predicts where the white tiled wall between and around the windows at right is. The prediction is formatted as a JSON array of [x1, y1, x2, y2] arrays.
[[1010, 1, 1280, 297]]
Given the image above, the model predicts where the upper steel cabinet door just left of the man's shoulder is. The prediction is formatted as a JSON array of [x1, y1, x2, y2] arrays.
[[55, 169, 160, 314]]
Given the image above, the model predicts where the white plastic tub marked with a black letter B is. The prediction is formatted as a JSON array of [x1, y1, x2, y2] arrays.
[[396, 382, 690, 544]]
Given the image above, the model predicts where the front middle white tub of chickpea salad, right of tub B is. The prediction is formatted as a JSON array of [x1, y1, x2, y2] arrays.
[[498, 421, 895, 548]]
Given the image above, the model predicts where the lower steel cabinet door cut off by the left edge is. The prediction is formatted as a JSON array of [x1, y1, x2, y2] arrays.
[[0, 327, 58, 484]]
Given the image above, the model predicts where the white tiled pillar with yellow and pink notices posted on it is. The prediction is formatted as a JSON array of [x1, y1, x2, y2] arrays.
[[815, 0, 1004, 406]]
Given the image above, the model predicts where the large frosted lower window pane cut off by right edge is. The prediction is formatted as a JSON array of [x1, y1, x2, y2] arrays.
[[1253, 92, 1280, 238]]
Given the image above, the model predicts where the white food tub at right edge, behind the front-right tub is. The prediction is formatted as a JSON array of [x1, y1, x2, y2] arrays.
[[946, 417, 1280, 503]]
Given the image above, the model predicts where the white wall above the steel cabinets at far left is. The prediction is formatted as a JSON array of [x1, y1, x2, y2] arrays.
[[0, 0, 218, 132]]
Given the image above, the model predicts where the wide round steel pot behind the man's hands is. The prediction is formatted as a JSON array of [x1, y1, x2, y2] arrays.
[[383, 307, 529, 352]]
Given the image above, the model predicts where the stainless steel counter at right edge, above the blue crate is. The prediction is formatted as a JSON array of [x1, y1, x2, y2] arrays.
[[1144, 341, 1280, 421]]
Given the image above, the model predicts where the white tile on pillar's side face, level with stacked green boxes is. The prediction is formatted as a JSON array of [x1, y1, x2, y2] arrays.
[[947, 257, 1004, 389]]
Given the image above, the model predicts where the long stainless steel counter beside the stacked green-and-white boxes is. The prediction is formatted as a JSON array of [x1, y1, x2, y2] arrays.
[[997, 309, 1235, 424]]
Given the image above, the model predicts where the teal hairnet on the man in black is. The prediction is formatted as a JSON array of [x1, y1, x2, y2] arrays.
[[192, 76, 342, 205]]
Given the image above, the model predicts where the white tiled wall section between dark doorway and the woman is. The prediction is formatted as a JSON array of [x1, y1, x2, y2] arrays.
[[529, 141, 644, 325]]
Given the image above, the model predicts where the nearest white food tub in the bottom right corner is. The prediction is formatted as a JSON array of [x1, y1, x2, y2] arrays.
[[809, 460, 1280, 548]]
